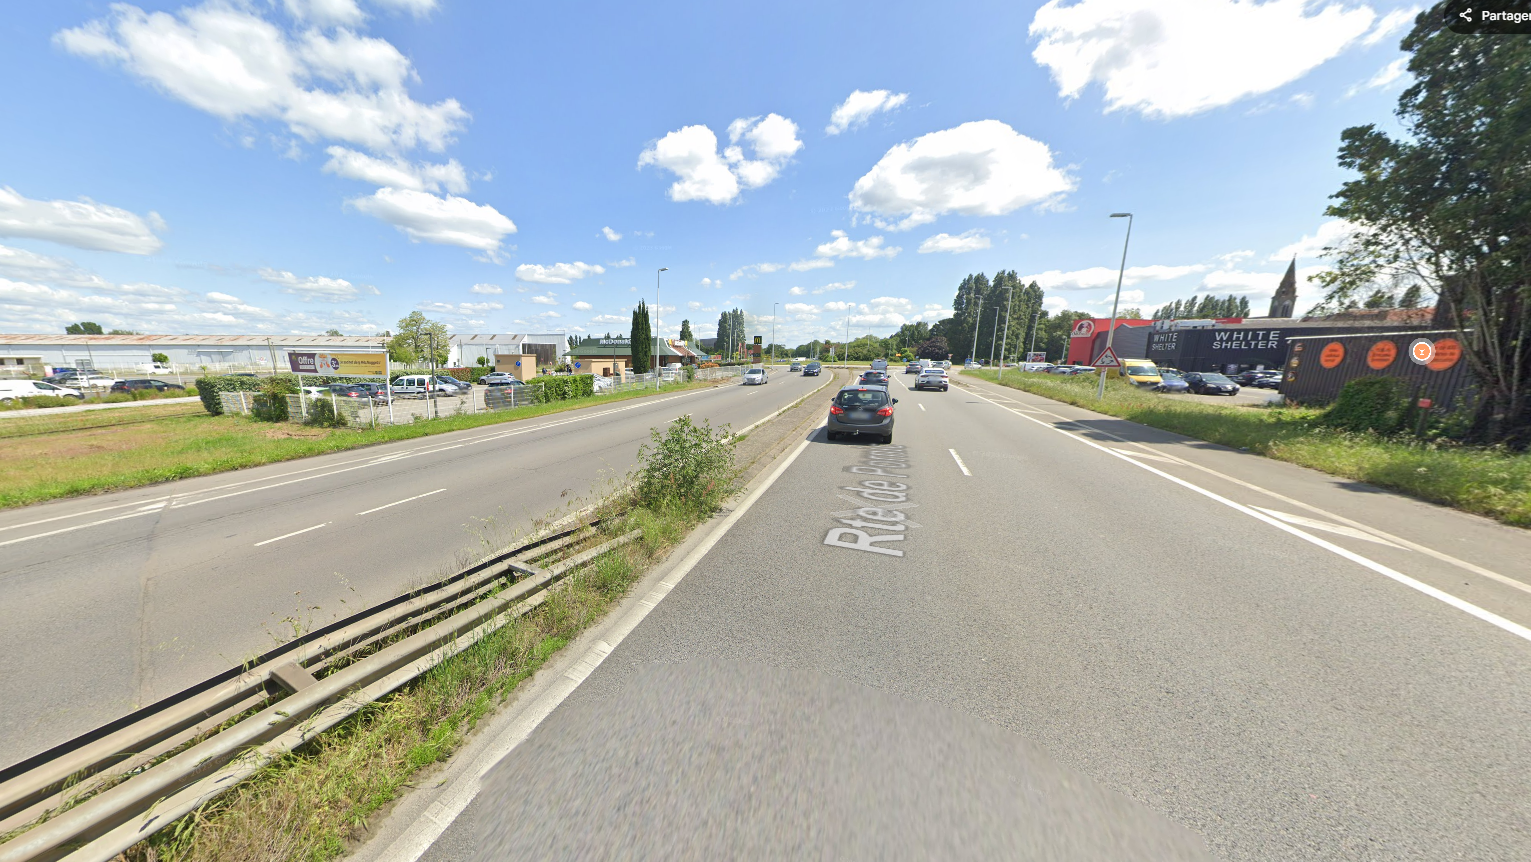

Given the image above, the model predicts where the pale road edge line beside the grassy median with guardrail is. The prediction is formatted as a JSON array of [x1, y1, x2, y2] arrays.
[[378, 426, 824, 862]]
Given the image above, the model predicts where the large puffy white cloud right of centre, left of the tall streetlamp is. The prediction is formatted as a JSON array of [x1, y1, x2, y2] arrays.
[[850, 119, 1075, 230]]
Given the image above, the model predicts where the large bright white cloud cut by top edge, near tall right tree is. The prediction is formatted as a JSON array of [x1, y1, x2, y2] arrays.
[[1030, 0, 1376, 118]]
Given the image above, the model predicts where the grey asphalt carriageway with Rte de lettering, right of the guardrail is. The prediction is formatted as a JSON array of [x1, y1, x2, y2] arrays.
[[410, 368, 1531, 862]]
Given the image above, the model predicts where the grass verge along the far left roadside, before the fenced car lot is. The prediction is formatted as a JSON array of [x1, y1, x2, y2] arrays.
[[0, 381, 717, 508]]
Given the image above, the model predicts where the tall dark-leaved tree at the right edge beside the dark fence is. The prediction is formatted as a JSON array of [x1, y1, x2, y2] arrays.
[[1317, 12, 1531, 450]]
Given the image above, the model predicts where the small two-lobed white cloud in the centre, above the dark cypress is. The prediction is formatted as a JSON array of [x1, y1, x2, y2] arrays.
[[638, 113, 802, 204]]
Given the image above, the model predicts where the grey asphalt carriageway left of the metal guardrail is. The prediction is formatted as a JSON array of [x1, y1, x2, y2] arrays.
[[0, 372, 821, 767]]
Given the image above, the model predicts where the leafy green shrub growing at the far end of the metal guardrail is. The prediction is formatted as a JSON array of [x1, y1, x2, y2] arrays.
[[634, 416, 739, 514]]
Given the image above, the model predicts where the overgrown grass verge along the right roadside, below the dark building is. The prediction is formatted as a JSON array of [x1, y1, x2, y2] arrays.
[[963, 371, 1531, 527]]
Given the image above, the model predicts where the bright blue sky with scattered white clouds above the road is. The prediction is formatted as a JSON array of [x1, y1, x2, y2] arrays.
[[0, 0, 1418, 343]]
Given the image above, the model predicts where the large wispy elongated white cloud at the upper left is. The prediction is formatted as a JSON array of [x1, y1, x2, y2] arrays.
[[54, 0, 468, 152]]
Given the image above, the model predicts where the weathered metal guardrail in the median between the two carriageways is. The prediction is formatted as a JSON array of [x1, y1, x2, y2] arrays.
[[0, 521, 640, 862]]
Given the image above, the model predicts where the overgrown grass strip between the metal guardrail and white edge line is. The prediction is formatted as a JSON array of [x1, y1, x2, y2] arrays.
[[110, 416, 738, 862]]
